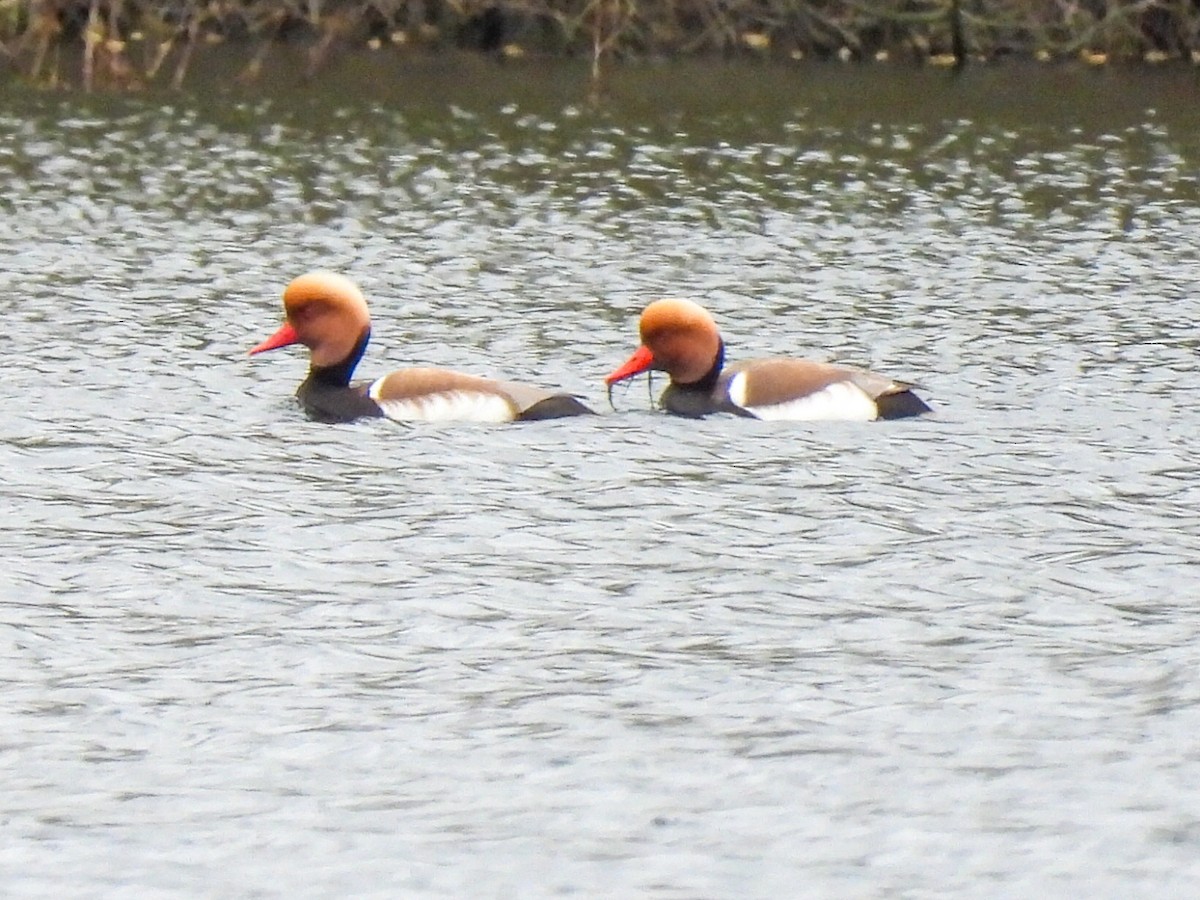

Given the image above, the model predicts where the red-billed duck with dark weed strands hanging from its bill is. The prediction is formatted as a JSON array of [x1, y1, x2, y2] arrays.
[[605, 299, 932, 421]]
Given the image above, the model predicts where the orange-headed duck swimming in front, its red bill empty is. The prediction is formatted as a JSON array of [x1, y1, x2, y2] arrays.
[[250, 271, 592, 422]]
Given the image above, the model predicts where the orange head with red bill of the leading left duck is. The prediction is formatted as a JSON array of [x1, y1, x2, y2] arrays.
[[251, 271, 371, 366]]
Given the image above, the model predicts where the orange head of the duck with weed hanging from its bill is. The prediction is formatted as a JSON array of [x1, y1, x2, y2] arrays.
[[605, 300, 721, 385]]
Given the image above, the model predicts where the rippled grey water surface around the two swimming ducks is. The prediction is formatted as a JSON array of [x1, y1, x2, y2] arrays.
[[0, 61, 1200, 898]]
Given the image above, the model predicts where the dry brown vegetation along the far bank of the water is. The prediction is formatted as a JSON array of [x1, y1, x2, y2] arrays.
[[0, 0, 1200, 89]]
